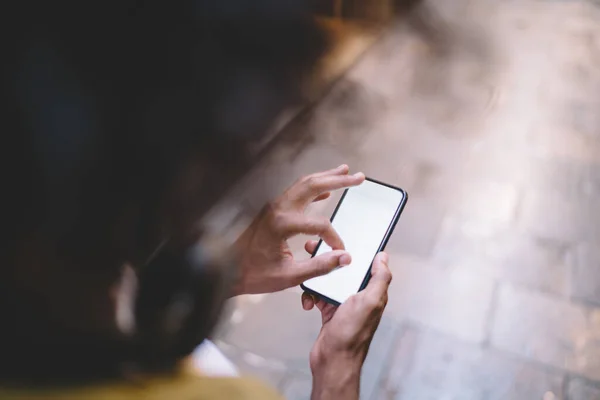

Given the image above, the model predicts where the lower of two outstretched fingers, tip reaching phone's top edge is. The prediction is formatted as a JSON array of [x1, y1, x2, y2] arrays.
[[289, 172, 365, 206]]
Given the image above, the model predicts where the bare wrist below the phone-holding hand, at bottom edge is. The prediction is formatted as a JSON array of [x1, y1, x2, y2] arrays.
[[311, 354, 361, 400]]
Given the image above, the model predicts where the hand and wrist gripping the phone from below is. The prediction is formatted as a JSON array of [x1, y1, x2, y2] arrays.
[[302, 250, 392, 400]]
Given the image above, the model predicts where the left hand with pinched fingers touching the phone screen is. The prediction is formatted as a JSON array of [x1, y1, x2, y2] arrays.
[[234, 165, 365, 295]]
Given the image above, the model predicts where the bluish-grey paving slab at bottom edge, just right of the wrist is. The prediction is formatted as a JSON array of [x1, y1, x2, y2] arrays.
[[378, 328, 564, 400]]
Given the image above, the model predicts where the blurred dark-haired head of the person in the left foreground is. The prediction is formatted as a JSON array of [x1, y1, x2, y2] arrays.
[[0, 0, 323, 381]]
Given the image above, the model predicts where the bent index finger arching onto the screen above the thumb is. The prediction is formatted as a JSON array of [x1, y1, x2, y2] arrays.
[[275, 213, 344, 250]]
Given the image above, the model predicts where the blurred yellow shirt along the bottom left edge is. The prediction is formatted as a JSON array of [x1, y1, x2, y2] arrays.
[[0, 374, 283, 400]]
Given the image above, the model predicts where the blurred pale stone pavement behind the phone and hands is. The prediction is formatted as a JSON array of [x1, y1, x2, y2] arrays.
[[204, 0, 600, 400]]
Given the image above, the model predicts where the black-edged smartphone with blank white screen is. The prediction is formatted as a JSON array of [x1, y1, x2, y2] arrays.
[[300, 178, 408, 305]]
